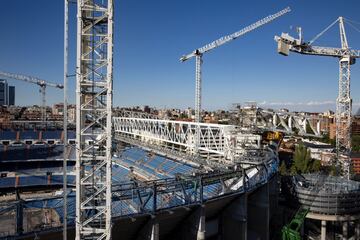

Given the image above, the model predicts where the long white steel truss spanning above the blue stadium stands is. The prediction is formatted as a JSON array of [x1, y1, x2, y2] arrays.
[[113, 117, 286, 164]]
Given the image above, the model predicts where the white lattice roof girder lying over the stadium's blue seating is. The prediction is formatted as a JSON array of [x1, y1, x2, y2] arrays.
[[113, 118, 258, 161]]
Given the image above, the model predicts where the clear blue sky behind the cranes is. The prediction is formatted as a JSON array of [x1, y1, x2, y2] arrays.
[[0, 0, 360, 111]]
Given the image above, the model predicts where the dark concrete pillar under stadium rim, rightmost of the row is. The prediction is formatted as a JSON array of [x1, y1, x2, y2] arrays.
[[247, 183, 270, 240]]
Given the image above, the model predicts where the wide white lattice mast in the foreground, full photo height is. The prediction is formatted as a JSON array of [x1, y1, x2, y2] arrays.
[[76, 0, 113, 240]]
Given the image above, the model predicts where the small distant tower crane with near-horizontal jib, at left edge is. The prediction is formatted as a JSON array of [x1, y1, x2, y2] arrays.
[[0, 71, 64, 122]]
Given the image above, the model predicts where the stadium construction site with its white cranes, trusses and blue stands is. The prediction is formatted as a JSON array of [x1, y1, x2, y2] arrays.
[[0, 0, 360, 240]]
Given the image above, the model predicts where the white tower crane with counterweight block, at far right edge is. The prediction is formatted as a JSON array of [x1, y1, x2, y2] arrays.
[[275, 17, 360, 177]]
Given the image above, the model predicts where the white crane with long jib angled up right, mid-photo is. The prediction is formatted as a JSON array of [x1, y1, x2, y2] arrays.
[[180, 7, 291, 148]]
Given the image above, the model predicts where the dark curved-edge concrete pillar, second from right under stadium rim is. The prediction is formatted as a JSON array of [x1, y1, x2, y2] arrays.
[[219, 194, 248, 240]]
